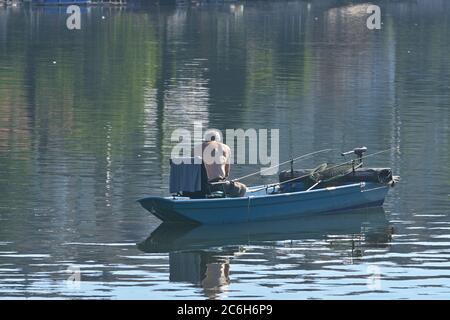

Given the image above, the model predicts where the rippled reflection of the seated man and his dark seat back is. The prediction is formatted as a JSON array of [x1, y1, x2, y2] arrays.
[[169, 249, 232, 299]]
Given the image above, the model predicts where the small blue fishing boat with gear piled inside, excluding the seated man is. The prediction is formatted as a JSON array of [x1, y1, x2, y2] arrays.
[[138, 148, 396, 224]]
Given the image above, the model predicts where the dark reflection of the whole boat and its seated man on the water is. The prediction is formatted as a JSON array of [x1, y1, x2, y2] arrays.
[[138, 208, 393, 298]]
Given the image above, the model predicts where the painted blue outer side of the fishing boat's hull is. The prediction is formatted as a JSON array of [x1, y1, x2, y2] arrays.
[[138, 182, 389, 224]]
